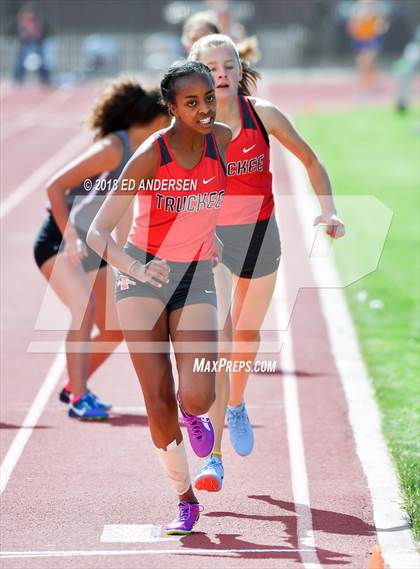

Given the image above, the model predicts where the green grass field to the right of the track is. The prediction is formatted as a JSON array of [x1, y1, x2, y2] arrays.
[[296, 108, 420, 539]]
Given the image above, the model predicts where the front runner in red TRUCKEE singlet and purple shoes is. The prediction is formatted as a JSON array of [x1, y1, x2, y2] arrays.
[[88, 61, 231, 534]]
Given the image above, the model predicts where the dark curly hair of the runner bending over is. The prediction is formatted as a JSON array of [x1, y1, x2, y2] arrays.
[[88, 79, 167, 140]]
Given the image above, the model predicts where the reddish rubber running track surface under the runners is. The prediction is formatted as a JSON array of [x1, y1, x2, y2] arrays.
[[0, 82, 394, 569]]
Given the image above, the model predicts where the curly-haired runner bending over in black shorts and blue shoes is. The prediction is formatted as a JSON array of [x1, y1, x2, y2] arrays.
[[34, 80, 169, 420]]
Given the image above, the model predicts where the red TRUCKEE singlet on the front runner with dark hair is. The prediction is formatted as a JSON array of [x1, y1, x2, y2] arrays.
[[128, 132, 226, 262]]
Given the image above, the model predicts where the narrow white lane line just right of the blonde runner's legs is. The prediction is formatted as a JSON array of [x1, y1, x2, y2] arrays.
[[277, 263, 321, 569]]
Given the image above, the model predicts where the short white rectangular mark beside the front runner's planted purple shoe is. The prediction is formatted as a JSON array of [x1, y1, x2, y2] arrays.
[[100, 524, 178, 543]]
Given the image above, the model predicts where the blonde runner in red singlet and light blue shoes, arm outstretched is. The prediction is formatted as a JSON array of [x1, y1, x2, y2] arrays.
[[189, 34, 344, 491]]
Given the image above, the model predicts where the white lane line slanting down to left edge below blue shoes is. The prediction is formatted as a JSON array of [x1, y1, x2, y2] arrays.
[[0, 348, 66, 494]]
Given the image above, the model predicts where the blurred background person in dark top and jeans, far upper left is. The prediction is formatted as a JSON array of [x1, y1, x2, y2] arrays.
[[13, 6, 51, 85]]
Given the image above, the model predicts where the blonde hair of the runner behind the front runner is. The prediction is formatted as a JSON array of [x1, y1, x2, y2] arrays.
[[188, 34, 261, 96]]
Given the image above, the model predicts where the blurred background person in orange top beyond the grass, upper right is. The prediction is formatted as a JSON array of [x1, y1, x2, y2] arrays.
[[347, 0, 389, 94]]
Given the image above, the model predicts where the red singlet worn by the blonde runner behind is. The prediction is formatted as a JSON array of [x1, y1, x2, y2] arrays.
[[217, 95, 274, 225]]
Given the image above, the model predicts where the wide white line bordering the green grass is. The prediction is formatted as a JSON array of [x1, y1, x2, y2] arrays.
[[285, 148, 420, 569]]
